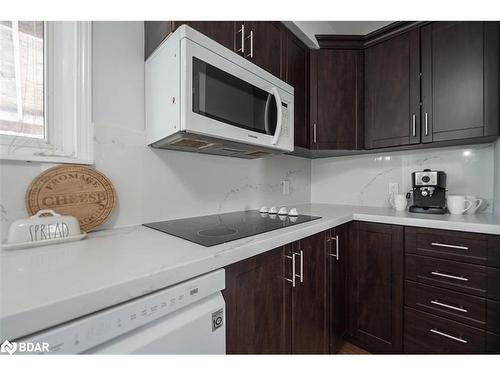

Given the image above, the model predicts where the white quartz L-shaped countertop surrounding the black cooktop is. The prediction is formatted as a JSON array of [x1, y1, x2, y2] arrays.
[[0, 204, 500, 342]]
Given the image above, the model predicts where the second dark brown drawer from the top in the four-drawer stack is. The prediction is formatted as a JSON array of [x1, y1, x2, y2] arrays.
[[405, 254, 487, 297]]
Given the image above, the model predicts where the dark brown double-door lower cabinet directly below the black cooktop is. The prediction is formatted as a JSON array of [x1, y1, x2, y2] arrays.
[[223, 232, 329, 354]]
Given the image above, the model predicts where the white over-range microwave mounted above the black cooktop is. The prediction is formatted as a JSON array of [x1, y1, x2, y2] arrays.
[[145, 25, 294, 159]]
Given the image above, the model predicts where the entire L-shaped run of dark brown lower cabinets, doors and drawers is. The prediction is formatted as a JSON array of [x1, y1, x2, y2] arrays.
[[227, 221, 500, 354]]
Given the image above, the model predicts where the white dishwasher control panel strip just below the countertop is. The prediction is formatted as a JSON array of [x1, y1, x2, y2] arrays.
[[16, 269, 225, 354]]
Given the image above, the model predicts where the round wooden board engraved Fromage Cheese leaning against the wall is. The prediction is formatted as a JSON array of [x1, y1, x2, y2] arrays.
[[25, 164, 116, 232]]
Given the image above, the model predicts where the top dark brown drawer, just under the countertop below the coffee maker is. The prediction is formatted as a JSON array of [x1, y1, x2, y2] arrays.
[[405, 227, 488, 265]]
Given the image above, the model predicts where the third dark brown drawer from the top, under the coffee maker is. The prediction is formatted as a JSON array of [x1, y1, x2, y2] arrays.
[[405, 281, 486, 329]]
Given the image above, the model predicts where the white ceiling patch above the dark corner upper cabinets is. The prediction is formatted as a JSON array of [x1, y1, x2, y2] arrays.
[[285, 21, 394, 48]]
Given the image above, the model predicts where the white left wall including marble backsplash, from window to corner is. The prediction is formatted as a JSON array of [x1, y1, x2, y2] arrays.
[[0, 22, 310, 240]]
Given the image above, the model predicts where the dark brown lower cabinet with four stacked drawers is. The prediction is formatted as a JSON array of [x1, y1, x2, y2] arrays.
[[404, 227, 500, 354]]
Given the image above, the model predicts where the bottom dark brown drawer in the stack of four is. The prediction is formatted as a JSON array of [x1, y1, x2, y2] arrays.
[[404, 307, 486, 354]]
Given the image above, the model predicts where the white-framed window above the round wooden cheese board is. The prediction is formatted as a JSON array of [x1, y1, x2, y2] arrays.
[[0, 21, 93, 164]]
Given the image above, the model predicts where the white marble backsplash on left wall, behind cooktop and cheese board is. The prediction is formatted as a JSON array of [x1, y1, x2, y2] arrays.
[[0, 125, 311, 240]]
